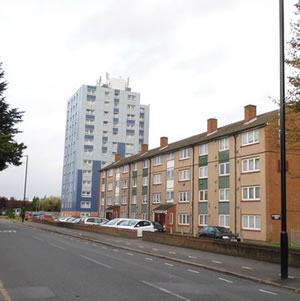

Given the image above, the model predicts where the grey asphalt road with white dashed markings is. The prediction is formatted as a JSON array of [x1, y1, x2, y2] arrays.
[[0, 220, 299, 301]]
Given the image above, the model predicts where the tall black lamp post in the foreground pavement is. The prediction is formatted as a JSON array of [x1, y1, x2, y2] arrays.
[[279, 0, 288, 279]]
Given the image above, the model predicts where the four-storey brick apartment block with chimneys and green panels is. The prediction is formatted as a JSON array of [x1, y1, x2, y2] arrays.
[[99, 105, 300, 241]]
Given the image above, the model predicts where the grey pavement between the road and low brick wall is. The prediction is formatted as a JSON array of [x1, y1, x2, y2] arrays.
[[24, 221, 300, 294]]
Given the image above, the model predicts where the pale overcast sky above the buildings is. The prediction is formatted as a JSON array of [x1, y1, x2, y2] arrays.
[[0, 0, 297, 199]]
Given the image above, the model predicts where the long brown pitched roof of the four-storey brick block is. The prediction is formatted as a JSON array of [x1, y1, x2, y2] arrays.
[[101, 110, 279, 171]]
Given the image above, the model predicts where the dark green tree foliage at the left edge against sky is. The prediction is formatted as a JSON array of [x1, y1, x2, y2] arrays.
[[0, 63, 26, 171]]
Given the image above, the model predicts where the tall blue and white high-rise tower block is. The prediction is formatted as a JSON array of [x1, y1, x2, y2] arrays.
[[61, 76, 149, 216]]
